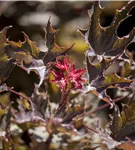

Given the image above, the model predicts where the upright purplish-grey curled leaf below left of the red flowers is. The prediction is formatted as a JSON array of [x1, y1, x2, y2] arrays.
[[12, 86, 50, 124]]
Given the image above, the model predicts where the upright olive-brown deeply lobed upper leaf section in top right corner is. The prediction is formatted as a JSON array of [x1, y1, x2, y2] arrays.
[[85, 0, 135, 56]]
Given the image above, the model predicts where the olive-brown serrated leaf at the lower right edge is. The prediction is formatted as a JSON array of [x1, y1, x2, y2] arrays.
[[110, 83, 135, 141]]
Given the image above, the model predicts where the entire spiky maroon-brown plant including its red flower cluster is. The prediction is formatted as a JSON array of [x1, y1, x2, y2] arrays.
[[0, 0, 135, 150]]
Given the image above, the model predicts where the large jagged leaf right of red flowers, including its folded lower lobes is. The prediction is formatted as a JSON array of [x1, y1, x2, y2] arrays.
[[83, 0, 135, 102]]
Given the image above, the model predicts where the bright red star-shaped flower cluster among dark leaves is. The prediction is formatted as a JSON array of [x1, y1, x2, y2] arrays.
[[51, 56, 85, 91]]
